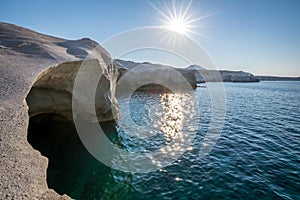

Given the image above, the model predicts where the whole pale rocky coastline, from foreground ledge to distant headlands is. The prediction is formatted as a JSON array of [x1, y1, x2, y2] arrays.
[[0, 23, 299, 199]]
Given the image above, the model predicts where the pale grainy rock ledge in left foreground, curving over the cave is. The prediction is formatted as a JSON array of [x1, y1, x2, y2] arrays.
[[0, 23, 118, 199]]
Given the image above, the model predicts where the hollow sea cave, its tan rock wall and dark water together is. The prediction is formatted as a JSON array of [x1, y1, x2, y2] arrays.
[[26, 59, 121, 199]]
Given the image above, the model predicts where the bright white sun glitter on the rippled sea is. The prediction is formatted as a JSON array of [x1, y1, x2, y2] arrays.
[[147, 93, 197, 166]]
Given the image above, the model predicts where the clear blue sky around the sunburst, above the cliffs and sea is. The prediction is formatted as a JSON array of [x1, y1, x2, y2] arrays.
[[0, 0, 300, 76]]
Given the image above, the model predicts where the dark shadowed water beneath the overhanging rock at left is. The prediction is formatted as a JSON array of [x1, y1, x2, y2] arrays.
[[28, 114, 131, 199]]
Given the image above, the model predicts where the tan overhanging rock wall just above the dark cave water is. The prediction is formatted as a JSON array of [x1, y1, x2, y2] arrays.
[[26, 59, 119, 122]]
